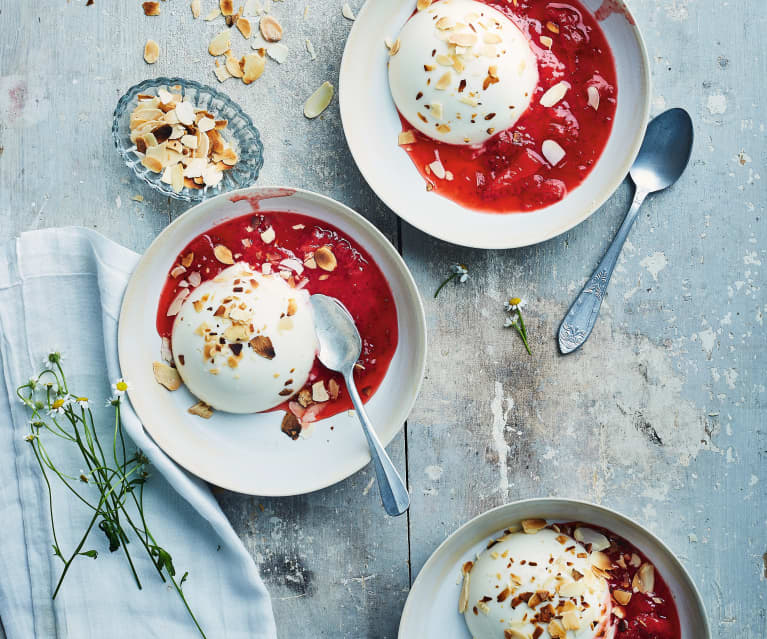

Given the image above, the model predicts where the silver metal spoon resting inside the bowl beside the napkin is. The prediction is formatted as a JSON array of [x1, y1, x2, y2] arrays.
[[311, 295, 410, 517]]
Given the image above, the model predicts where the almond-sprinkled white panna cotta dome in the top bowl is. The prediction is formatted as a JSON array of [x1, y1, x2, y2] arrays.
[[389, 0, 538, 145]]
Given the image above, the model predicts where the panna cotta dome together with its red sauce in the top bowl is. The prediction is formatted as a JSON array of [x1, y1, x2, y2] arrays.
[[389, 0, 617, 213]]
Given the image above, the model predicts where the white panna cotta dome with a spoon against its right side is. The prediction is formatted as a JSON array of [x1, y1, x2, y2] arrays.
[[172, 262, 318, 413]]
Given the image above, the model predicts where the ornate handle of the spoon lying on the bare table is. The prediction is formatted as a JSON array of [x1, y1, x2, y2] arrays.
[[559, 188, 648, 355]]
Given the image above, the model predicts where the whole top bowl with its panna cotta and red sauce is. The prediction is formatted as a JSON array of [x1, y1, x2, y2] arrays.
[[339, 0, 650, 248]]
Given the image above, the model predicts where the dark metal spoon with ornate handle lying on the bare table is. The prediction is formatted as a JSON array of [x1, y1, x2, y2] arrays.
[[559, 109, 693, 355]]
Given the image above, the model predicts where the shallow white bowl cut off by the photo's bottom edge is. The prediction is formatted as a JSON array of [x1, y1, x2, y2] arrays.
[[398, 498, 711, 639]]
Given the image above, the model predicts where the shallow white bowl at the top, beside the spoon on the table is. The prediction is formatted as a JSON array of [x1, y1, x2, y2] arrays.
[[339, 0, 650, 249]]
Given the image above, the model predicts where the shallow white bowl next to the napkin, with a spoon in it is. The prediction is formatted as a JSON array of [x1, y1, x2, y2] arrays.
[[118, 187, 426, 496]]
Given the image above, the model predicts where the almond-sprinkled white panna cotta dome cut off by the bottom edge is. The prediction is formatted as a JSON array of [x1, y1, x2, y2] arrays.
[[464, 528, 613, 639]]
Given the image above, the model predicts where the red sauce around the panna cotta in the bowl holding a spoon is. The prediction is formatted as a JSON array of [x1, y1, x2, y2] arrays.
[[157, 211, 398, 432]]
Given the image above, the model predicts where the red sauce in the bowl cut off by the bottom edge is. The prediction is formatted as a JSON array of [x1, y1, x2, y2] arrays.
[[557, 523, 682, 639]]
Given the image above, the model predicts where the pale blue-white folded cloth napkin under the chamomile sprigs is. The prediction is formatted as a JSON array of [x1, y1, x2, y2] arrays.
[[0, 228, 276, 639]]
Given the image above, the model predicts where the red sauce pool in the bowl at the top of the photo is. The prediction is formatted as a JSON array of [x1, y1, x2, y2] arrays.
[[400, 0, 617, 213]]
